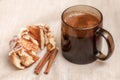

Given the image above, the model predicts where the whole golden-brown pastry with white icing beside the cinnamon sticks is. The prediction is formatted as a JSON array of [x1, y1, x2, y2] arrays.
[[9, 25, 56, 69]]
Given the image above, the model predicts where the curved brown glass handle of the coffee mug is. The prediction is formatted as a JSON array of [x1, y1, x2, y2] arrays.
[[96, 28, 115, 60]]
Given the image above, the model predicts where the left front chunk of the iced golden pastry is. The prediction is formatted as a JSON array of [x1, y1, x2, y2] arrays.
[[9, 28, 39, 69]]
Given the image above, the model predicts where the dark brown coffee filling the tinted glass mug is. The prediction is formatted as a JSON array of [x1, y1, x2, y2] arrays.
[[62, 13, 101, 64]]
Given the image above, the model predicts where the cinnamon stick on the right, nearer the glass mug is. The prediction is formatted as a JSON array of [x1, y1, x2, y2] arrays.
[[44, 48, 58, 74]]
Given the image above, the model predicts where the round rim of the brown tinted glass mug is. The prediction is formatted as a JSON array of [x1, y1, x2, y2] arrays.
[[61, 5, 103, 30]]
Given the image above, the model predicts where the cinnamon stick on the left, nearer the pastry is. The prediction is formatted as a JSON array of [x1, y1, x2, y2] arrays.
[[34, 52, 50, 75]]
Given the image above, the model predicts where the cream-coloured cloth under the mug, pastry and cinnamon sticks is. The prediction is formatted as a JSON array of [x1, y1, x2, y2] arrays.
[[0, 0, 120, 80]]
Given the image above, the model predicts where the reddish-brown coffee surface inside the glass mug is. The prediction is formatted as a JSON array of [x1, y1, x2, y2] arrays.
[[65, 13, 99, 28]]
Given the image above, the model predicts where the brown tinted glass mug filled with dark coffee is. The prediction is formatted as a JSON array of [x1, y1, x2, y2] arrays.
[[61, 5, 114, 64]]
